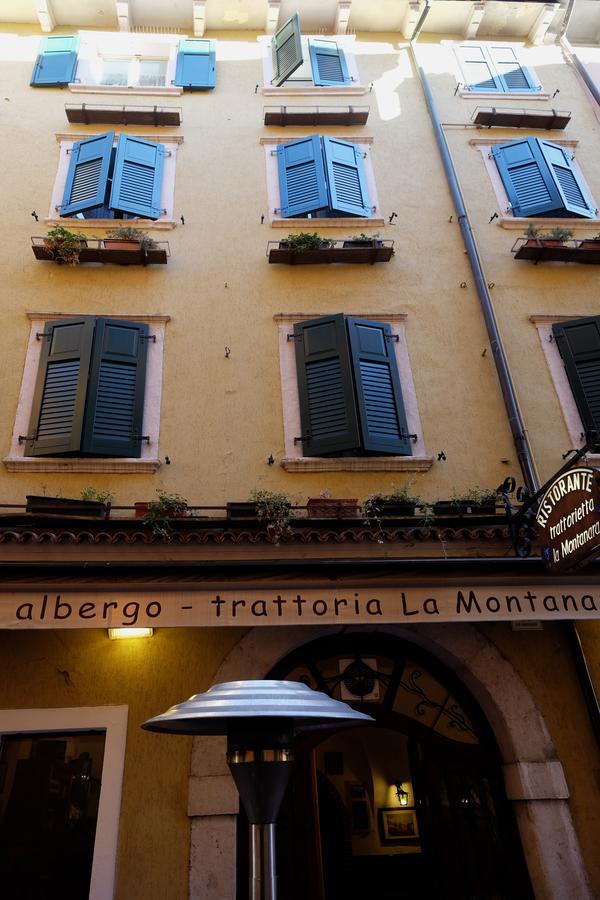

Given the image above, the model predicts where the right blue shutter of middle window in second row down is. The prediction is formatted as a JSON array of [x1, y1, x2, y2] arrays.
[[323, 137, 372, 216]]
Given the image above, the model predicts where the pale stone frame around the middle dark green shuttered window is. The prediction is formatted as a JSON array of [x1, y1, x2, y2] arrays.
[[273, 312, 433, 472]]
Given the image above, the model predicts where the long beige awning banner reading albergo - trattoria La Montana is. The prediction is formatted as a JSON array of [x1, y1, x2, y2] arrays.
[[0, 582, 600, 629]]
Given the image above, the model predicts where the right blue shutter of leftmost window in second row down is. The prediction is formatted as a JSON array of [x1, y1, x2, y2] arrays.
[[109, 134, 165, 219]]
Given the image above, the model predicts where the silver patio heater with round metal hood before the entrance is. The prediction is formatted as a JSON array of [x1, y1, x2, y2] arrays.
[[142, 681, 373, 900]]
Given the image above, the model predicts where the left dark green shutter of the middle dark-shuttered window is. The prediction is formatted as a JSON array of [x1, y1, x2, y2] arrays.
[[294, 315, 360, 456]]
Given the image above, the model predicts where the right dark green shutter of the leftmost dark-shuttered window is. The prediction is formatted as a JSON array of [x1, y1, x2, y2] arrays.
[[82, 318, 148, 457]]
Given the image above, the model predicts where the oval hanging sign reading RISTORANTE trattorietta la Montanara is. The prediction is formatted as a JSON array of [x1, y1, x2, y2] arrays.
[[535, 467, 600, 572]]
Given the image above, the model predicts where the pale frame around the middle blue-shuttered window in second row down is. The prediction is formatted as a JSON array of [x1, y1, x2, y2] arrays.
[[260, 134, 385, 231]]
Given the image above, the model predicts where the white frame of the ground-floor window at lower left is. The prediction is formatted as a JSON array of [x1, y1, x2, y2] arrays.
[[0, 706, 128, 900]]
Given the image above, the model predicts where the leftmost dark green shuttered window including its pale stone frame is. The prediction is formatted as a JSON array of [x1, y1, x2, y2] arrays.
[[4, 313, 168, 472]]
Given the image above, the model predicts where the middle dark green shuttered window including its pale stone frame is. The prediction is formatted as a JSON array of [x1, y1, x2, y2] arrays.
[[275, 313, 432, 472]]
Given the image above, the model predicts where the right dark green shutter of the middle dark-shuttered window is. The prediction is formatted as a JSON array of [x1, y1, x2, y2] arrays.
[[346, 317, 412, 456]]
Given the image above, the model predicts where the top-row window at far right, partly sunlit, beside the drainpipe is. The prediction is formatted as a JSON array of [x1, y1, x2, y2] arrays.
[[455, 43, 541, 94]]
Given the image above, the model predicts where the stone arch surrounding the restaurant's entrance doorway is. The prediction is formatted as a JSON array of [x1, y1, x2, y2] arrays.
[[188, 624, 593, 900]]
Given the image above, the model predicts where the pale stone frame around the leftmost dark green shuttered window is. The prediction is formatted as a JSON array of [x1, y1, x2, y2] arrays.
[[2, 311, 170, 475]]
